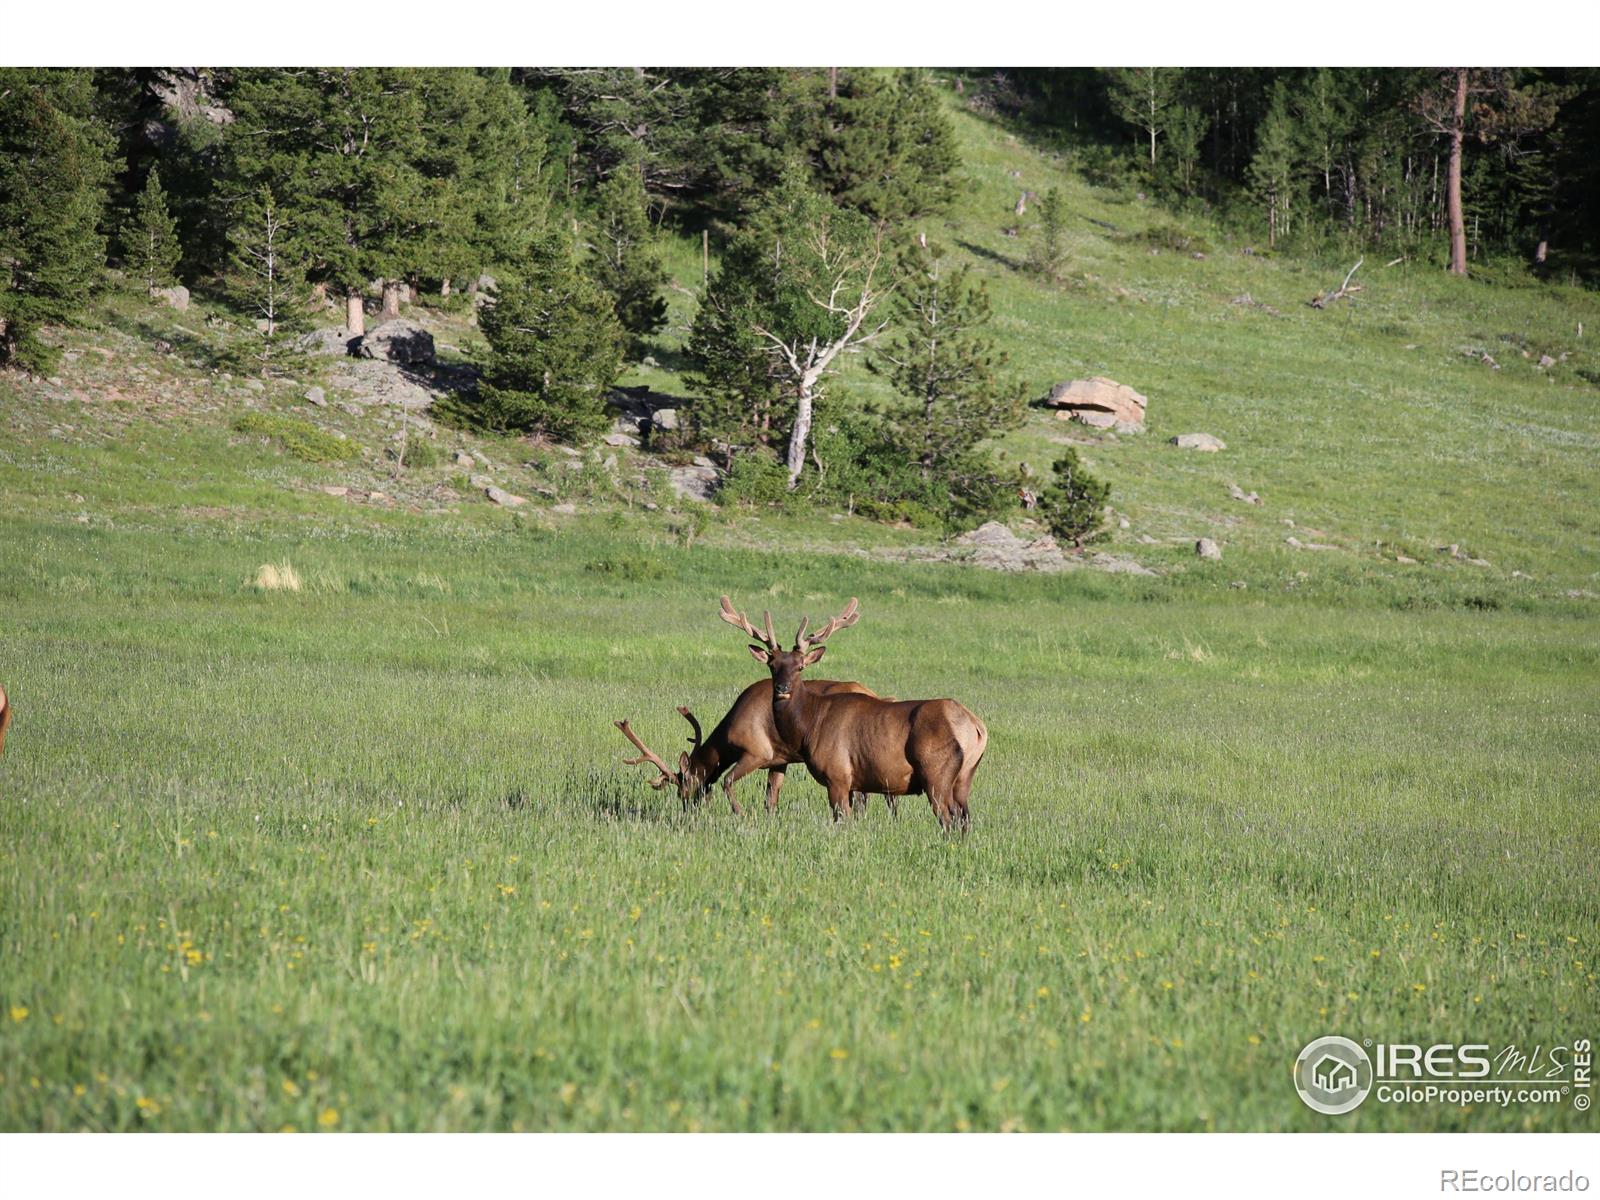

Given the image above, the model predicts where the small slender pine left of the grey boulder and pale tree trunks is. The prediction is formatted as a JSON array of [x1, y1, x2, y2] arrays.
[[229, 187, 310, 373]]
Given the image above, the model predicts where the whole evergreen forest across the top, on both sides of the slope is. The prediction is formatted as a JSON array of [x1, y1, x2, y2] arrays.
[[9, 67, 1600, 541]]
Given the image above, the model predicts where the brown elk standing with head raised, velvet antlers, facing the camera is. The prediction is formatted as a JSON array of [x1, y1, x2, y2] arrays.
[[720, 597, 989, 832]]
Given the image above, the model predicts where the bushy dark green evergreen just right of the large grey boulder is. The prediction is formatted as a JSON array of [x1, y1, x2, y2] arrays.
[[478, 235, 622, 440]]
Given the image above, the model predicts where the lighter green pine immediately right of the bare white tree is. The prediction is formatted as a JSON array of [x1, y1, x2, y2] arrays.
[[869, 245, 1022, 515]]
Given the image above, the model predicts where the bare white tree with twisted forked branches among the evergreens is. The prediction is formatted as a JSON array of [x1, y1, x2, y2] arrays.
[[752, 222, 893, 490]]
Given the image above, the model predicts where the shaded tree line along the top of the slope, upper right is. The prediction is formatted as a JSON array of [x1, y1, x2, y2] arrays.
[[1011, 67, 1600, 278]]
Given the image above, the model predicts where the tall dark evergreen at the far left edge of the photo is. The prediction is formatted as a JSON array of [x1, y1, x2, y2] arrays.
[[0, 67, 110, 373]]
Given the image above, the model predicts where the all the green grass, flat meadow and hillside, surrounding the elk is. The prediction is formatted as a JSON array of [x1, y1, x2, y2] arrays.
[[0, 89, 1600, 1131]]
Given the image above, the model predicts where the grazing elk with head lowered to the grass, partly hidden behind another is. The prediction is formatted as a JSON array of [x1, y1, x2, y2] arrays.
[[613, 678, 893, 814]]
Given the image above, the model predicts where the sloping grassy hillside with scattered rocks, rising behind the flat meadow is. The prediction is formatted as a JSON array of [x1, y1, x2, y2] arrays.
[[0, 86, 1600, 603]]
